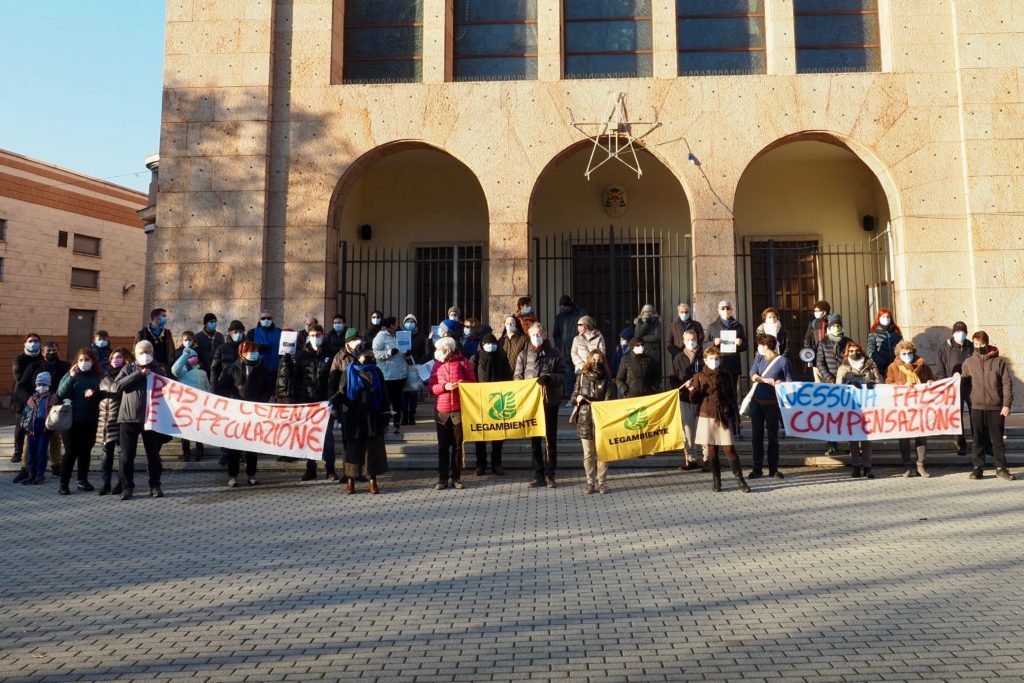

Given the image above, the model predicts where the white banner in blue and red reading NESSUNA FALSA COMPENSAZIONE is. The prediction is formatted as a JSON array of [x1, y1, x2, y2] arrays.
[[775, 375, 963, 441]]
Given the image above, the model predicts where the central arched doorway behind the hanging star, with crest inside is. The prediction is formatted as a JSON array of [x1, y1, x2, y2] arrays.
[[529, 140, 691, 358]]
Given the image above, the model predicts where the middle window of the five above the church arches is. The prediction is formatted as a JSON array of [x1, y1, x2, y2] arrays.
[[562, 0, 653, 78]]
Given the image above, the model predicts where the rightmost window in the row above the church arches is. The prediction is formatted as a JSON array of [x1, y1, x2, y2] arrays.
[[794, 0, 882, 74]]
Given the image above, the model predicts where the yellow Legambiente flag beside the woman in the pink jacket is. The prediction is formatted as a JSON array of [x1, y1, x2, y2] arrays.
[[459, 379, 545, 442]]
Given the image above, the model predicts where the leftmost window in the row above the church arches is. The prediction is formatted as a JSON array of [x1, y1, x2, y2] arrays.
[[342, 0, 423, 83]]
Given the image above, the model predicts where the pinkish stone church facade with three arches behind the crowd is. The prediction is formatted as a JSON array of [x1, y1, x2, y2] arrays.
[[150, 0, 1024, 401]]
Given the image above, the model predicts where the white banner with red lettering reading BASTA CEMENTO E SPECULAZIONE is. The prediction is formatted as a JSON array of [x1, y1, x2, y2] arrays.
[[145, 375, 331, 460]]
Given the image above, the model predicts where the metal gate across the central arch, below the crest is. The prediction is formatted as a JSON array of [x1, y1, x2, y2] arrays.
[[530, 225, 691, 372]]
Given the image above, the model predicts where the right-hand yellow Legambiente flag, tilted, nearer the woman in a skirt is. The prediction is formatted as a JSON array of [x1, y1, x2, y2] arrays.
[[590, 389, 683, 463]]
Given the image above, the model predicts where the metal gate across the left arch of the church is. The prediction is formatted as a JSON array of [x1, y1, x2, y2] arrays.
[[338, 242, 487, 330]]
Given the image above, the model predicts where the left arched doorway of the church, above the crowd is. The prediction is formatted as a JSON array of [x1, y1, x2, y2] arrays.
[[332, 141, 487, 330]]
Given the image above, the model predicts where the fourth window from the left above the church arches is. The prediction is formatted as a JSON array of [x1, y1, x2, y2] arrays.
[[676, 0, 767, 76]]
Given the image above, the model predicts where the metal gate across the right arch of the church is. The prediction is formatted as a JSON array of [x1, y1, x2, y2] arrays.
[[736, 228, 895, 378]]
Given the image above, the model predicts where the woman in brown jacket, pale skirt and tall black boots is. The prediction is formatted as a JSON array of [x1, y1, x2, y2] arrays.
[[683, 346, 751, 494]]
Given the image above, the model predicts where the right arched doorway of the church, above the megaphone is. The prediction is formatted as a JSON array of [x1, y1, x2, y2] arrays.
[[734, 133, 898, 370]]
